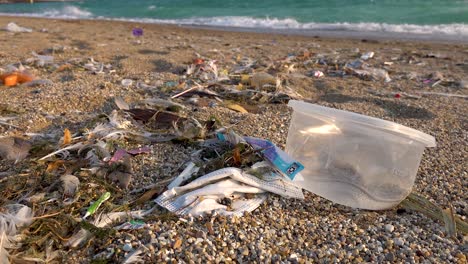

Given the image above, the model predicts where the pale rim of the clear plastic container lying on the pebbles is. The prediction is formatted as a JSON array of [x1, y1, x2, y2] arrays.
[[288, 100, 436, 147]]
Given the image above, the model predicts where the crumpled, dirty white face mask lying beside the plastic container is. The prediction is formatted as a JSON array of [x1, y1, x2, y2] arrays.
[[155, 168, 304, 216]]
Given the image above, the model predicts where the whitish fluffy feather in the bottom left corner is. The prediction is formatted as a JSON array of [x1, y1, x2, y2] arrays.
[[0, 204, 33, 263]]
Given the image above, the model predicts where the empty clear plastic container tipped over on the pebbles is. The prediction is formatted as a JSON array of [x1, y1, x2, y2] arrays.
[[286, 100, 435, 210]]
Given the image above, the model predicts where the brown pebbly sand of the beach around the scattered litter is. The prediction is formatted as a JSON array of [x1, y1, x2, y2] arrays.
[[0, 16, 468, 263]]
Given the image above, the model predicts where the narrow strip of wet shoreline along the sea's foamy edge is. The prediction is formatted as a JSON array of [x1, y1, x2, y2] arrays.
[[0, 13, 468, 44]]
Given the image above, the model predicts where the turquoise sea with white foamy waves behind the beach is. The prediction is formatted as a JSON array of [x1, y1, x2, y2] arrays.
[[0, 0, 468, 37]]
